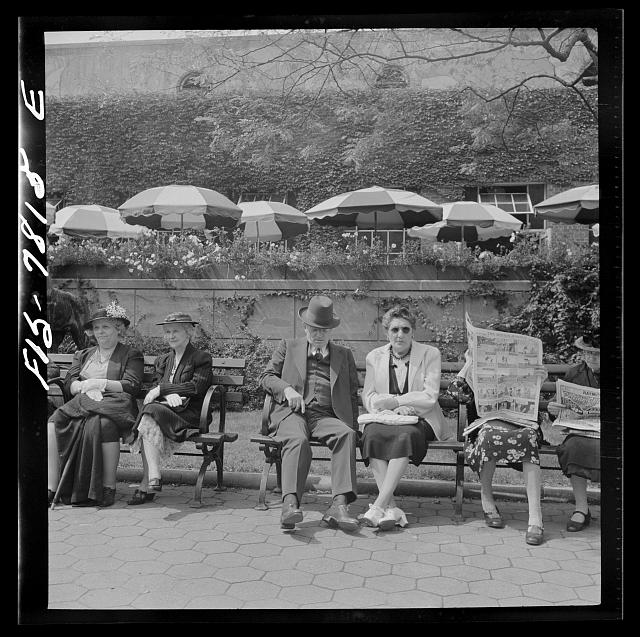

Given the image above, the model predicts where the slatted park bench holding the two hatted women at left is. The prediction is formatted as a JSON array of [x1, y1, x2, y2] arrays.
[[48, 354, 246, 508]]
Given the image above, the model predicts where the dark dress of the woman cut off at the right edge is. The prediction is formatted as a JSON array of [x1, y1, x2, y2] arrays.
[[556, 361, 600, 482]]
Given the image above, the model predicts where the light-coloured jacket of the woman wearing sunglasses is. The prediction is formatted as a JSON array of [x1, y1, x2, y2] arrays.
[[362, 341, 447, 440]]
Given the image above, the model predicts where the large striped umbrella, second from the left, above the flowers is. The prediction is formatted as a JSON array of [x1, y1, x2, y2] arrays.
[[118, 185, 242, 230]]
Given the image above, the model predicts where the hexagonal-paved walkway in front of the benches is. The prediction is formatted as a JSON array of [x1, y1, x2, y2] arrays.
[[49, 483, 600, 610]]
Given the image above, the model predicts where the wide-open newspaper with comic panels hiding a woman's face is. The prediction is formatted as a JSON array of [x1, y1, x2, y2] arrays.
[[464, 314, 542, 435]]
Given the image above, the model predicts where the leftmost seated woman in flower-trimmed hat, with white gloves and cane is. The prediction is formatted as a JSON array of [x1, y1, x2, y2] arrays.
[[47, 301, 144, 507]]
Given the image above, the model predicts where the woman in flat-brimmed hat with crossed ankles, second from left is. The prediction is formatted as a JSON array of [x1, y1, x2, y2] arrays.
[[127, 312, 212, 505]]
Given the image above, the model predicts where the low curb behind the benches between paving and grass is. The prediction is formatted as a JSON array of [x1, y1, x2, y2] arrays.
[[117, 467, 600, 504]]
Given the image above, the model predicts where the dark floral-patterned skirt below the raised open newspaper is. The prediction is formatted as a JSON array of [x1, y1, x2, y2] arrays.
[[464, 420, 541, 473]]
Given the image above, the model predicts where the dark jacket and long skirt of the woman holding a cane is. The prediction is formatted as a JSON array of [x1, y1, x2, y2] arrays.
[[49, 343, 144, 504]]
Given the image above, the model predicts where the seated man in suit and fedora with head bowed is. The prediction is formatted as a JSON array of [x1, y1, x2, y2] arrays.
[[260, 295, 358, 532]]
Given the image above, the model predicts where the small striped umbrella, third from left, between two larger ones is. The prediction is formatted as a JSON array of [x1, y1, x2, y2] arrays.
[[238, 201, 309, 243]]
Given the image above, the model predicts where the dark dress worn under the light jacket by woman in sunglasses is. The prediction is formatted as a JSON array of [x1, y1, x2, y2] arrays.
[[361, 355, 436, 467]]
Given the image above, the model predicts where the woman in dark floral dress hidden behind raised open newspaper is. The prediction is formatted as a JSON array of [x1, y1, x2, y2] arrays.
[[449, 350, 546, 545]]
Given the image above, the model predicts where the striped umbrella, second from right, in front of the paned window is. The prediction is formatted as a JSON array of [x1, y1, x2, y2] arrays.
[[407, 201, 522, 244]]
